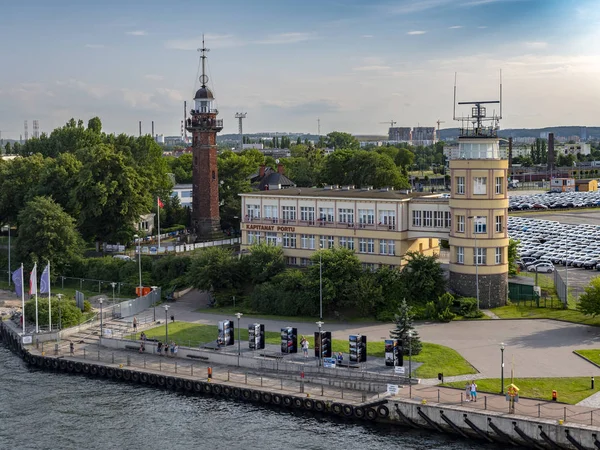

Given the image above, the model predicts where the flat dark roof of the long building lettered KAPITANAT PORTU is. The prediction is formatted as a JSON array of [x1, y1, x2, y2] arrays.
[[240, 187, 434, 202]]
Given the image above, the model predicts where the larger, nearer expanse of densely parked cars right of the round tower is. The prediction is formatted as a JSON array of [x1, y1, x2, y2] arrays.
[[508, 216, 600, 273]]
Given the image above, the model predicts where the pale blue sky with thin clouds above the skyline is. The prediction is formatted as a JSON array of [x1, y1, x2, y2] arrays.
[[0, 0, 600, 139]]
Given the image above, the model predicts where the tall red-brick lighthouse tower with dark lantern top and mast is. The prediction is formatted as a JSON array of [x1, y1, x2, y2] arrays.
[[186, 38, 223, 241]]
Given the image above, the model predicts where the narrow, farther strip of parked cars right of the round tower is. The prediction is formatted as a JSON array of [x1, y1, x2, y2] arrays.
[[508, 191, 600, 211]]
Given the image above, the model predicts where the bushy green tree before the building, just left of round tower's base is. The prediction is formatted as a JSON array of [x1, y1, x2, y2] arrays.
[[400, 252, 446, 304]]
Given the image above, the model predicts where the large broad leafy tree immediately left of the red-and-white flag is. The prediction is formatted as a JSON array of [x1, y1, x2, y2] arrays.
[[73, 144, 153, 242]]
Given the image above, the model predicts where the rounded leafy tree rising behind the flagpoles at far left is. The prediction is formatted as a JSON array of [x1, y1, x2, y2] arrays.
[[16, 197, 83, 273]]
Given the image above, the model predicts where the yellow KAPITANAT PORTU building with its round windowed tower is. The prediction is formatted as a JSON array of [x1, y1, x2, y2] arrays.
[[240, 138, 508, 308]]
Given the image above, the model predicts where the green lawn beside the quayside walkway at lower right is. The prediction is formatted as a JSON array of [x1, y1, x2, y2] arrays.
[[443, 377, 600, 405]]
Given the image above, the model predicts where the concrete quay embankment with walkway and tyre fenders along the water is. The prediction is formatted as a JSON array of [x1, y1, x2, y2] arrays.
[[0, 323, 600, 450]]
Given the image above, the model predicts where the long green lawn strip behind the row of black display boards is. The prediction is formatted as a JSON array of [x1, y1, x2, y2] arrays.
[[138, 322, 476, 378]]
